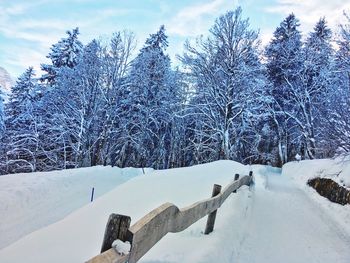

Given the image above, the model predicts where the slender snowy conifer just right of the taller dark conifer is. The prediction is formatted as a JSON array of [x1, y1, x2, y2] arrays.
[[300, 18, 333, 159]]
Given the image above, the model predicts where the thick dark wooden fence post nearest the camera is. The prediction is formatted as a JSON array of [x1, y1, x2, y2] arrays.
[[101, 214, 131, 253]]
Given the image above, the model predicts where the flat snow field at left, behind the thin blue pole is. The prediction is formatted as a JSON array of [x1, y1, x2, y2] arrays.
[[0, 166, 142, 251]]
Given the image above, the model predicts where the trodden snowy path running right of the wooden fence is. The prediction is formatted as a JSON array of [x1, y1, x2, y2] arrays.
[[232, 169, 350, 263]]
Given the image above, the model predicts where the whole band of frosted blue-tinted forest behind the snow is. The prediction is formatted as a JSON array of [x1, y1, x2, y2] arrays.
[[0, 8, 350, 174]]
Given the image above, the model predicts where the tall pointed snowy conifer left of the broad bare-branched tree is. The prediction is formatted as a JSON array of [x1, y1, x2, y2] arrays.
[[124, 26, 183, 168]]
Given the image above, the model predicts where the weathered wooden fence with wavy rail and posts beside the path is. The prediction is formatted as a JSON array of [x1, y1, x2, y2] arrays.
[[86, 172, 253, 263]]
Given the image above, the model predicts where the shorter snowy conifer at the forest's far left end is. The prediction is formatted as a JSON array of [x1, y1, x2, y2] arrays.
[[5, 67, 40, 172]]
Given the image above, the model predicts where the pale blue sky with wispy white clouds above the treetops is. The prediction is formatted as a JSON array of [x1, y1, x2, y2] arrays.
[[0, 0, 350, 78]]
